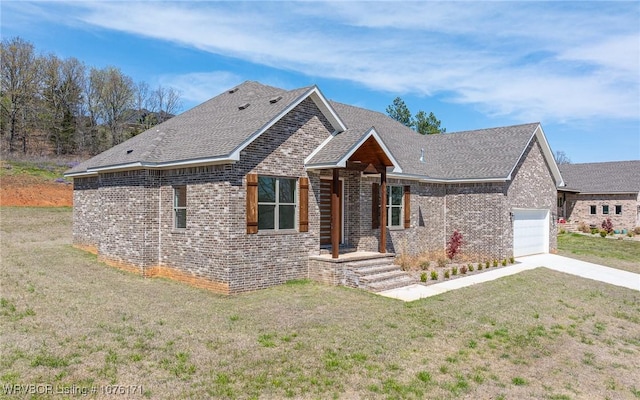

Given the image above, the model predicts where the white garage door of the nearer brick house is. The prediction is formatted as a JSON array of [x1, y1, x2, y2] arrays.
[[513, 209, 549, 257]]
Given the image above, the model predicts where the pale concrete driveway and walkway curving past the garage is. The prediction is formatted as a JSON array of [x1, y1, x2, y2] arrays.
[[378, 254, 640, 301]]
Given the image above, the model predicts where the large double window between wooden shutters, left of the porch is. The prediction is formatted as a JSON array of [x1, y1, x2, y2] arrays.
[[258, 176, 296, 230]]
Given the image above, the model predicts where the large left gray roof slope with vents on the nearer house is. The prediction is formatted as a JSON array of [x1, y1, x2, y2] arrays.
[[67, 81, 311, 173]]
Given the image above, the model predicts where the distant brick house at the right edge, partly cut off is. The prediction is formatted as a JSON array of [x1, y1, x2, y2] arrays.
[[558, 160, 640, 230]]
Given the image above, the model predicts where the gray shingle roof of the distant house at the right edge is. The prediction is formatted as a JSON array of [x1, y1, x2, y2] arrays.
[[558, 160, 640, 194]]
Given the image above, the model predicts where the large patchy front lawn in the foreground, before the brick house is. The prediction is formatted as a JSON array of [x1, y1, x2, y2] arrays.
[[0, 208, 640, 399]]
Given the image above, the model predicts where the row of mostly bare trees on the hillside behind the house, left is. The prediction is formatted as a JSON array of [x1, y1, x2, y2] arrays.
[[0, 37, 182, 155]]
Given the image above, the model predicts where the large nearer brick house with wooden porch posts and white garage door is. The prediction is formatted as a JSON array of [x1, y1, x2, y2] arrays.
[[66, 82, 562, 293]]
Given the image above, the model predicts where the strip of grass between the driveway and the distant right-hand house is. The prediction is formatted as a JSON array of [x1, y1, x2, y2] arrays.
[[558, 233, 640, 273]]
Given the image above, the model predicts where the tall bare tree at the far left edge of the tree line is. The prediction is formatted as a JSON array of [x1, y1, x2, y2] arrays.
[[0, 37, 40, 153]]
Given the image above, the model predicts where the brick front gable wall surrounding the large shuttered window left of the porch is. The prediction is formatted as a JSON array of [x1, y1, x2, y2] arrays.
[[216, 99, 333, 292]]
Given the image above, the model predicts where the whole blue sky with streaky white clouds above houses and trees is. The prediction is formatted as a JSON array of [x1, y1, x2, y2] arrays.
[[1, 0, 640, 162]]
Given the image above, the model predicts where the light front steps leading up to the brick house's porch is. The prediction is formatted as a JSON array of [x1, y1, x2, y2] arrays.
[[345, 257, 415, 292]]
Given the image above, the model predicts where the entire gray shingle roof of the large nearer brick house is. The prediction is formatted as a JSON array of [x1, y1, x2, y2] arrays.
[[67, 81, 552, 180]]
